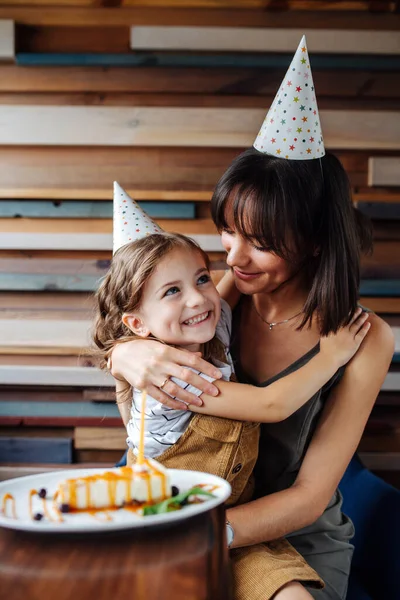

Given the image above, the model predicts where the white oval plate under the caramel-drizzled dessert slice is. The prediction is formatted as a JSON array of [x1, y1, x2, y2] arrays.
[[0, 469, 231, 533]]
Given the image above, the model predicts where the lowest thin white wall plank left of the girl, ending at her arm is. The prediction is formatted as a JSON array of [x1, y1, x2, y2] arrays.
[[0, 365, 115, 386]]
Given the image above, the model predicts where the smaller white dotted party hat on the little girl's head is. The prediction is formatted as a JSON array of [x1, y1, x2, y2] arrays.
[[113, 181, 164, 254]]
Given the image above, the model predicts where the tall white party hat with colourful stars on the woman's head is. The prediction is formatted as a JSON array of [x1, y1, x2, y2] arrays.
[[254, 35, 325, 160]]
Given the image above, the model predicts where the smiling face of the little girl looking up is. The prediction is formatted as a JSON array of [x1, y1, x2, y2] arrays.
[[130, 248, 221, 352]]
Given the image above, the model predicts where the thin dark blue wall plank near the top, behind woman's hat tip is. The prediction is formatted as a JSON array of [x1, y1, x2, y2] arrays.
[[15, 52, 399, 72]]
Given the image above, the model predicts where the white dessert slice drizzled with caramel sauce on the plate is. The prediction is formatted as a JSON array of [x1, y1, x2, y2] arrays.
[[54, 459, 172, 512]]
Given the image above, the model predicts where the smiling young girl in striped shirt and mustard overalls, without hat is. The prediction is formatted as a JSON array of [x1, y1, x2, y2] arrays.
[[95, 185, 368, 600]]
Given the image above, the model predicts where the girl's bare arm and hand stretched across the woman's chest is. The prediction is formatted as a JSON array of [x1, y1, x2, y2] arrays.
[[192, 309, 370, 423]]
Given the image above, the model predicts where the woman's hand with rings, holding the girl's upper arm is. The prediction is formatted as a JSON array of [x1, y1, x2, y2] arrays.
[[111, 340, 221, 410]]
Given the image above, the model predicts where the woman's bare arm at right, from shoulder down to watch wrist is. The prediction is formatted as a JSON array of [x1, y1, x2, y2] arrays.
[[228, 315, 394, 547]]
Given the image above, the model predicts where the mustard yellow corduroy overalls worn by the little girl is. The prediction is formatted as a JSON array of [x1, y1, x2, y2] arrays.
[[128, 415, 323, 600]]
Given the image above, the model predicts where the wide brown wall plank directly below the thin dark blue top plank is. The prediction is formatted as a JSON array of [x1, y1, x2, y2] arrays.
[[0, 63, 400, 99]]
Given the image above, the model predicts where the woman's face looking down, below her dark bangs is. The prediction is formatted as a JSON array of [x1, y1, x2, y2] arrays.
[[221, 222, 297, 295]]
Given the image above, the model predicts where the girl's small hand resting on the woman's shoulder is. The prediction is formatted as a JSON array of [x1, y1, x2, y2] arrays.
[[320, 308, 371, 367]]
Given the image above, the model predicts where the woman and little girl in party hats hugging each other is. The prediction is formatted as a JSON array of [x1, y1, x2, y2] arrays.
[[94, 38, 394, 600]]
